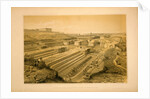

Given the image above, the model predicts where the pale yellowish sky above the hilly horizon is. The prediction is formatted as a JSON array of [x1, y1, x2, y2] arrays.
[[24, 15, 126, 34]]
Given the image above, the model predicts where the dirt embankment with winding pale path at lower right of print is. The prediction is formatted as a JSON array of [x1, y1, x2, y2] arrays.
[[85, 48, 127, 83]]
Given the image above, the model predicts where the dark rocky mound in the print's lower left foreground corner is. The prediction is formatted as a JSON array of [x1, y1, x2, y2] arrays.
[[24, 65, 62, 83]]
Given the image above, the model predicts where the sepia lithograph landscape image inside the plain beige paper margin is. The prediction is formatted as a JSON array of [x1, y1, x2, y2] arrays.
[[24, 14, 127, 84]]
